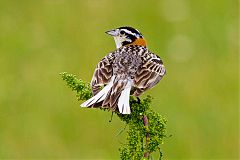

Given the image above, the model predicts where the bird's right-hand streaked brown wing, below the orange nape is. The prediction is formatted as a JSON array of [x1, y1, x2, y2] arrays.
[[133, 53, 166, 96]]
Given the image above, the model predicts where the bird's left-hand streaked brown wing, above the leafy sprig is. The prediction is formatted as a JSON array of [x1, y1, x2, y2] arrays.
[[91, 52, 115, 95]]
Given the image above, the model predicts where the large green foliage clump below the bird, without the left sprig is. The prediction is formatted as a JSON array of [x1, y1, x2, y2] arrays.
[[118, 96, 167, 160]]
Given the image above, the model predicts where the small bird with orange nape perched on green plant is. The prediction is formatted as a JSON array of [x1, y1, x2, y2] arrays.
[[80, 26, 166, 114]]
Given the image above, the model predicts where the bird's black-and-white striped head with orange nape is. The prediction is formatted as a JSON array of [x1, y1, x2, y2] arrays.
[[106, 27, 147, 48]]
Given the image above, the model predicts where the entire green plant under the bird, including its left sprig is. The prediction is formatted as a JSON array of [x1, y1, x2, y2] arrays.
[[60, 72, 167, 160]]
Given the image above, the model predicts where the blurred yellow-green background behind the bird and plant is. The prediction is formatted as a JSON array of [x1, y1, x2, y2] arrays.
[[0, 0, 239, 159]]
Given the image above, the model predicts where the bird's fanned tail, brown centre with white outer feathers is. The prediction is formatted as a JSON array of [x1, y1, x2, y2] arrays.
[[81, 76, 132, 114]]
